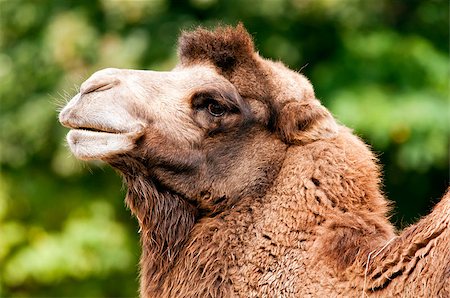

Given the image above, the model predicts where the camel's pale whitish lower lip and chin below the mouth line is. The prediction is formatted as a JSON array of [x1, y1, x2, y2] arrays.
[[67, 129, 142, 160]]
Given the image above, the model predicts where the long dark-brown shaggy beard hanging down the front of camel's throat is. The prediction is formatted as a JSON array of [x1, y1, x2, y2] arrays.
[[126, 177, 196, 293]]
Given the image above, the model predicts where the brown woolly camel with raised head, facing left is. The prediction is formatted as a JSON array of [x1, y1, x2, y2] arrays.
[[59, 25, 450, 297]]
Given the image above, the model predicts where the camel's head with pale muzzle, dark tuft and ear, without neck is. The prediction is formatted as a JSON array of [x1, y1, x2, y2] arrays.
[[59, 25, 338, 211]]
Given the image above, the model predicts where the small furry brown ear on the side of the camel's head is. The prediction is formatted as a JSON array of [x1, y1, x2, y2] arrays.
[[277, 99, 338, 144]]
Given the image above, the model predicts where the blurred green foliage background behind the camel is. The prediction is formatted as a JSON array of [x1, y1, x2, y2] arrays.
[[0, 0, 450, 297]]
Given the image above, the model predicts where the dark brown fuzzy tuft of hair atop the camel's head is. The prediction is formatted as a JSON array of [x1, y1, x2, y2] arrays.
[[178, 23, 255, 72]]
